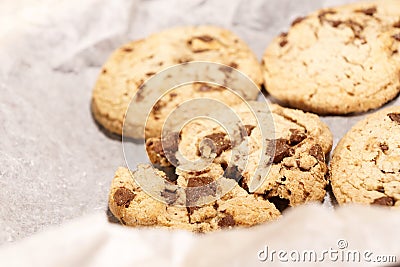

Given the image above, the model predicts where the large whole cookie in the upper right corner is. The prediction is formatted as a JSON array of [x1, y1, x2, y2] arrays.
[[262, 0, 400, 114]]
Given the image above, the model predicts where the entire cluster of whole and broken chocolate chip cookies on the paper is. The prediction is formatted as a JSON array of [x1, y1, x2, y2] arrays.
[[92, 0, 400, 232]]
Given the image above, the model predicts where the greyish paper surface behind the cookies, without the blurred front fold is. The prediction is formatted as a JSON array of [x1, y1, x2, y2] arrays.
[[0, 0, 398, 244]]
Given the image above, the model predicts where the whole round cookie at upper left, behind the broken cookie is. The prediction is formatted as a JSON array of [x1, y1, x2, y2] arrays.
[[92, 26, 263, 138]]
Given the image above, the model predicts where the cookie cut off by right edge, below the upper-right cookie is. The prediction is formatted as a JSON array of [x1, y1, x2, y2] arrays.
[[330, 107, 400, 207]]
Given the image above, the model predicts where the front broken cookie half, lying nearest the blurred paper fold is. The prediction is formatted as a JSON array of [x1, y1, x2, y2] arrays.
[[109, 165, 280, 232]]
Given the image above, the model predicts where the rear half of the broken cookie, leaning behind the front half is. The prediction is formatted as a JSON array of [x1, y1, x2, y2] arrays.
[[146, 101, 332, 209]]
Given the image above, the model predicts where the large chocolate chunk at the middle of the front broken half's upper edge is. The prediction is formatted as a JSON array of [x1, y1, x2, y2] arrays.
[[186, 177, 216, 206]]
